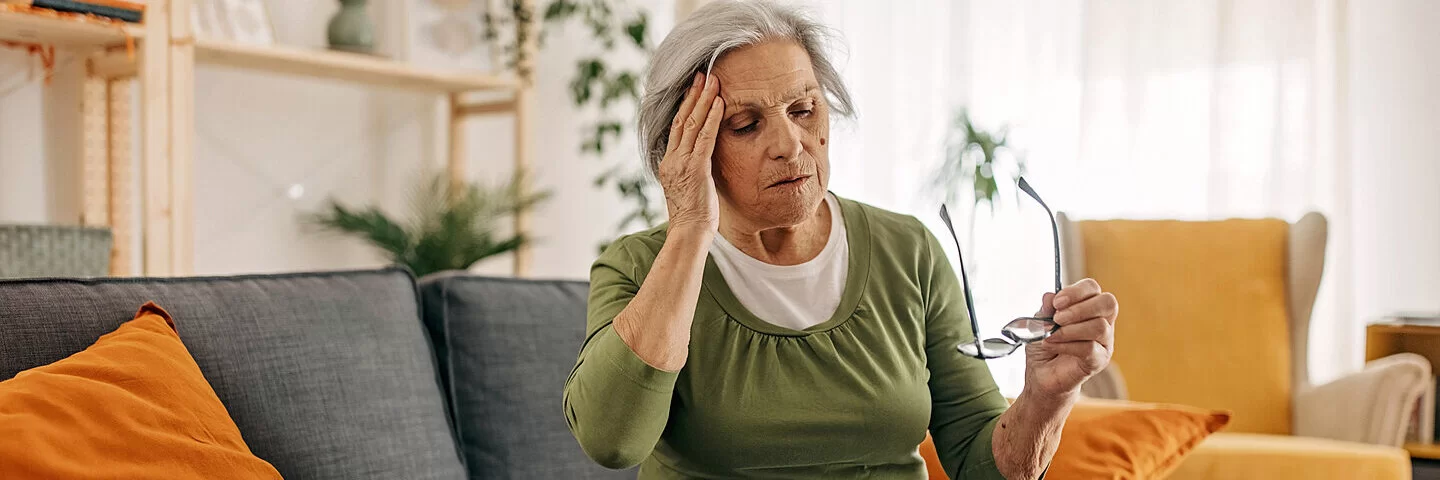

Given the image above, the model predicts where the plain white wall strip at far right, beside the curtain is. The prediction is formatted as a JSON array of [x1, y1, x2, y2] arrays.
[[1348, 0, 1440, 321]]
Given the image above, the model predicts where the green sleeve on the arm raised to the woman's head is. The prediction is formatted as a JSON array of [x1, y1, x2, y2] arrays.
[[564, 239, 677, 468]]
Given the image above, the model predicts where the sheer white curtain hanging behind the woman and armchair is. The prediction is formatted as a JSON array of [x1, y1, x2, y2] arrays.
[[794, 0, 1362, 395]]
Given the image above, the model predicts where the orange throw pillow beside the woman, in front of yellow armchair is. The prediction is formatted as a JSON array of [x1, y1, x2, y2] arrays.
[[920, 398, 1230, 480]]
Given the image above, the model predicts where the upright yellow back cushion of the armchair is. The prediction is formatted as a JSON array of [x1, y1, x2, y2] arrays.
[[1077, 219, 1292, 434]]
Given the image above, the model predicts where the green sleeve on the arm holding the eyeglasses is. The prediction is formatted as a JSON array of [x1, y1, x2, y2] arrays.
[[920, 226, 1008, 480]]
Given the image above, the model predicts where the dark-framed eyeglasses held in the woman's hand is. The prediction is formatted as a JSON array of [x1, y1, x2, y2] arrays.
[[940, 177, 1060, 359]]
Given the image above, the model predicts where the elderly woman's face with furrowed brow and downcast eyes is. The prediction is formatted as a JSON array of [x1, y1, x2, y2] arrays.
[[711, 42, 829, 229]]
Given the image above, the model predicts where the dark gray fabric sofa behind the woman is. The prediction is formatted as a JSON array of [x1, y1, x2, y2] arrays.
[[0, 268, 635, 479]]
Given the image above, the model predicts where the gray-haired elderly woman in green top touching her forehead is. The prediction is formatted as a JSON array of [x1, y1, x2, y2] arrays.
[[564, 1, 1117, 479]]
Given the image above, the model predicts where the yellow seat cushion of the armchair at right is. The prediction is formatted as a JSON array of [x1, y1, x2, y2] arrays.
[[1166, 432, 1410, 480]]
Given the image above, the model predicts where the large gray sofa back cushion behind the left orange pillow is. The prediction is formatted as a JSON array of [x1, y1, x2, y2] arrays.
[[0, 270, 464, 479]]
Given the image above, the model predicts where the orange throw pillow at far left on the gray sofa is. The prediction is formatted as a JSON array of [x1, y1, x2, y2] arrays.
[[0, 303, 281, 479]]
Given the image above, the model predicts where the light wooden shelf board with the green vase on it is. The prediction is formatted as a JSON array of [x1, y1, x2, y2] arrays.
[[194, 39, 518, 92]]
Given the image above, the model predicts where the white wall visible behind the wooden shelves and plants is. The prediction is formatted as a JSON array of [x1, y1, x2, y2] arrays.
[[0, 0, 671, 278]]
